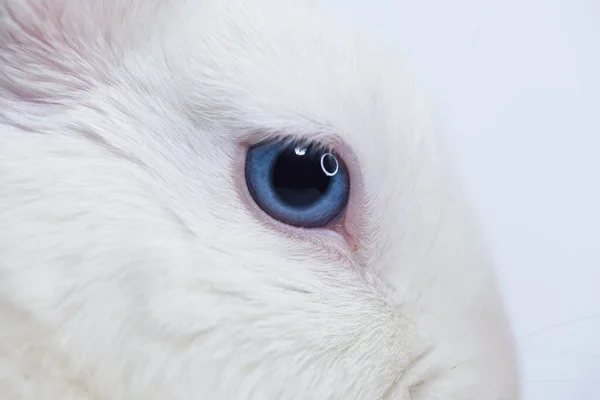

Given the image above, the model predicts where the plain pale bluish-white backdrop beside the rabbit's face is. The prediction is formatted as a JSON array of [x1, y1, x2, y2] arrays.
[[332, 0, 600, 400]]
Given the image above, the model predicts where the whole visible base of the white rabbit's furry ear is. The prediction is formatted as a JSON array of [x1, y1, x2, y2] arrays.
[[0, 0, 168, 103]]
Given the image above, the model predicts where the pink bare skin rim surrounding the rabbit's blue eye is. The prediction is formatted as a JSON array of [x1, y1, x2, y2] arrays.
[[233, 136, 364, 262]]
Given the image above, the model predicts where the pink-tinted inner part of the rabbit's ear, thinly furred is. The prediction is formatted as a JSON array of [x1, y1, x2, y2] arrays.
[[0, 0, 98, 104]]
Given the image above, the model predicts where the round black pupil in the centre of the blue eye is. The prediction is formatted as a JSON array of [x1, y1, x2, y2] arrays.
[[272, 147, 331, 207]]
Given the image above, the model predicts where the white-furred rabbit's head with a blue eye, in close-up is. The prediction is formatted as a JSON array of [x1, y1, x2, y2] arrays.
[[0, 0, 519, 400]]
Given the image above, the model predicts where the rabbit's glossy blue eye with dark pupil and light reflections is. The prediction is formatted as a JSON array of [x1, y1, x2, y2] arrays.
[[246, 141, 350, 228]]
